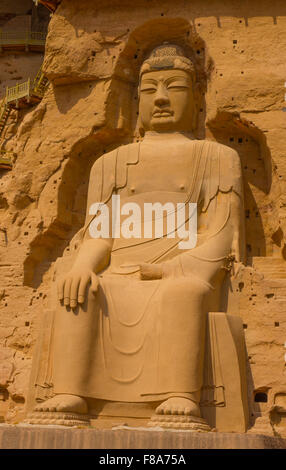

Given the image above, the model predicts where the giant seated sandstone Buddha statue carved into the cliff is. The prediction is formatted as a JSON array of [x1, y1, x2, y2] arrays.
[[27, 43, 249, 430]]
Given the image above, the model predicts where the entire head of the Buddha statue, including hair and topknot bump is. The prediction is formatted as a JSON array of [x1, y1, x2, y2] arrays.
[[139, 44, 196, 132]]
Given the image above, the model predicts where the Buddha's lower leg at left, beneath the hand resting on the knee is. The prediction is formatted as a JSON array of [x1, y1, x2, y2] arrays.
[[35, 282, 99, 414]]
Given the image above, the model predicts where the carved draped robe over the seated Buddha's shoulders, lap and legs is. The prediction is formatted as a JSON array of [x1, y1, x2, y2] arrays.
[[45, 141, 243, 402]]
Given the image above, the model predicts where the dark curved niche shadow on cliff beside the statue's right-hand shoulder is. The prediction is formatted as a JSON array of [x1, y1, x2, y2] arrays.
[[207, 112, 276, 258]]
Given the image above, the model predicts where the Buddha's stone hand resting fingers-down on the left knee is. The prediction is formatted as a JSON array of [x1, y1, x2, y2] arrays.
[[57, 269, 99, 308]]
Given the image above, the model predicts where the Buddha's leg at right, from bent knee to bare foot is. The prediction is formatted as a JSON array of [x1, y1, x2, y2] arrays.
[[152, 277, 209, 416]]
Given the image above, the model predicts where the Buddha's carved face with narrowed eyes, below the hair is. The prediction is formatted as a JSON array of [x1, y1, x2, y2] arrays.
[[139, 69, 194, 132]]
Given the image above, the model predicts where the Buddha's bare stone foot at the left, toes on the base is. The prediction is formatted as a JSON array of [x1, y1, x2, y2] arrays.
[[25, 394, 90, 426]]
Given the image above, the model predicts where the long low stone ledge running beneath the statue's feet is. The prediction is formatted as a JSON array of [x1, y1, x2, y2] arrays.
[[0, 424, 286, 450]]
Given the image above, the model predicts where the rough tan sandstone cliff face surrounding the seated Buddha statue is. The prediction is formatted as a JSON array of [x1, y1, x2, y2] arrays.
[[0, 0, 286, 436]]
